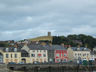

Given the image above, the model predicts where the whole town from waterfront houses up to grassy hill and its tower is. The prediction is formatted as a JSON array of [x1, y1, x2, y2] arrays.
[[0, 32, 96, 64]]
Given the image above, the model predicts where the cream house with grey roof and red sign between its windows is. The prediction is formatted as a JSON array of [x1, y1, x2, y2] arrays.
[[29, 45, 48, 63]]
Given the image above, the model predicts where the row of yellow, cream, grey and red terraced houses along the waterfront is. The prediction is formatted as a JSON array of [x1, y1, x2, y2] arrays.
[[0, 44, 93, 64]]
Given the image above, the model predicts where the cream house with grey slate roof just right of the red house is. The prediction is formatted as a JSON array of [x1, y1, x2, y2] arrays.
[[68, 47, 91, 61]]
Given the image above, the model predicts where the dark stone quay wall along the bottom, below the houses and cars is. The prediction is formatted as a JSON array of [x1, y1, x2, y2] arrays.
[[7, 63, 96, 72]]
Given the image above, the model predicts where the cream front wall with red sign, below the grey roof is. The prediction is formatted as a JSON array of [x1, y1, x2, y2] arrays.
[[30, 50, 48, 63]]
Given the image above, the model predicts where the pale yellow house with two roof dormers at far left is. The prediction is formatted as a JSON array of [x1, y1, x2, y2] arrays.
[[3, 47, 21, 64]]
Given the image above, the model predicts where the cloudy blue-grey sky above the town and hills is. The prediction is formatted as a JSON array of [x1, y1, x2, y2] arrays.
[[0, 0, 96, 40]]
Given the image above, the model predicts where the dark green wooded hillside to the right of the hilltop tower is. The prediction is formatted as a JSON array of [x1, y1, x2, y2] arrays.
[[52, 34, 96, 49]]
